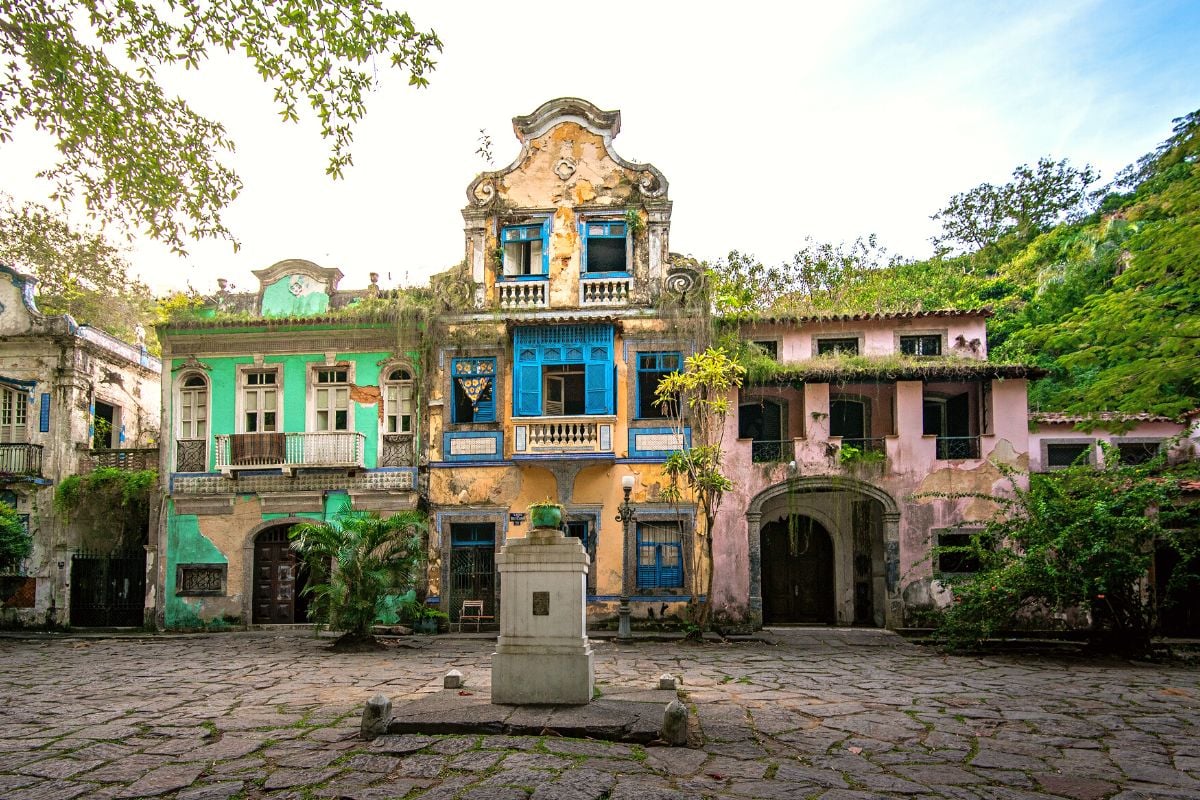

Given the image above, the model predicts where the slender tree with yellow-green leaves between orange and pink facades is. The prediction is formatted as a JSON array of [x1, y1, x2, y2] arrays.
[[654, 348, 745, 628]]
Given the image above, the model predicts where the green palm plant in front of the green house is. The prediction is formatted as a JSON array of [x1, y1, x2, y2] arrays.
[[288, 509, 427, 650]]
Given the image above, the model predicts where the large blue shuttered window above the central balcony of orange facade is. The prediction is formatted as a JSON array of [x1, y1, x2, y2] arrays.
[[512, 325, 616, 416]]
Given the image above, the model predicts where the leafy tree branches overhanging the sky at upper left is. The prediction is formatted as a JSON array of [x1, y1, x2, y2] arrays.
[[0, 0, 442, 253]]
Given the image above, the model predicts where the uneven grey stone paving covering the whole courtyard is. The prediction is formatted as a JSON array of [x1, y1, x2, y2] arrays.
[[0, 628, 1200, 800]]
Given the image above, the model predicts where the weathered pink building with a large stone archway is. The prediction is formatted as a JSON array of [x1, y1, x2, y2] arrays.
[[713, 312, 1031, 627]]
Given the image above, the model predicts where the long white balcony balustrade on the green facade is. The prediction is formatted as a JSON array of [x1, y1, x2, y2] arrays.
[[216, 431, 366, 475]]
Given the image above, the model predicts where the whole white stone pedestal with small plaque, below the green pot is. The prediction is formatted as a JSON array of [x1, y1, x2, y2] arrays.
[[492, 528, 595, 705]]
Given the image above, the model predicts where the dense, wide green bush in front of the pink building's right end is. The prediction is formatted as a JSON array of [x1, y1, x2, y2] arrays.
[[935, 452, 1200, 654]]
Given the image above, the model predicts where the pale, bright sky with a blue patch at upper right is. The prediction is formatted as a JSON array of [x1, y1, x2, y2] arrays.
[[0, 0, 1200, 291]]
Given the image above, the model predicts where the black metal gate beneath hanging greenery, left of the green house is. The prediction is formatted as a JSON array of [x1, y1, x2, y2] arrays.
[[71, 548, 146, 627]]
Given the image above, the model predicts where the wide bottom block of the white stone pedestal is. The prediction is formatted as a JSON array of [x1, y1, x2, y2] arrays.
[[492, 648, 595, 705]]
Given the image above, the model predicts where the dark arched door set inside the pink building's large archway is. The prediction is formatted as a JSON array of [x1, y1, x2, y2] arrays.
[[761, 515, 834, 625]]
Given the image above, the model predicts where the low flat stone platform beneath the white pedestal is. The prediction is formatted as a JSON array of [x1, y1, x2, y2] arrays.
[[388, 690, 676, 745]]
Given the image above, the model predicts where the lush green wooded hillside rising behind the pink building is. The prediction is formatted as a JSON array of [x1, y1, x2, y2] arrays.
[[713, 110, 1200, 416]]
